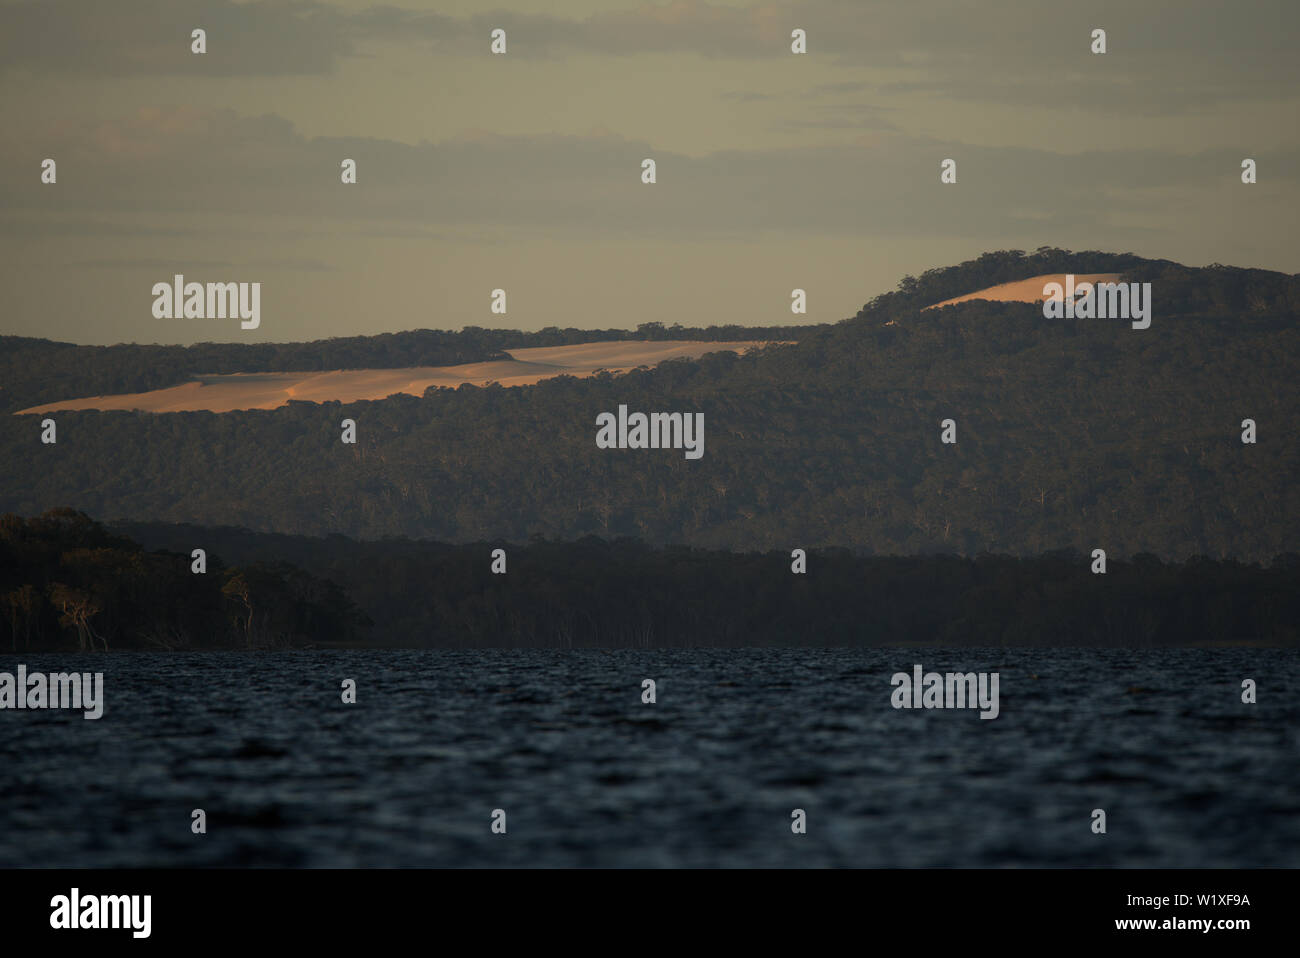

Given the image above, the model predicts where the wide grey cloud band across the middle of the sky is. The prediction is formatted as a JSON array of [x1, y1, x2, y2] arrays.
[[0, 104, 1300, 239]]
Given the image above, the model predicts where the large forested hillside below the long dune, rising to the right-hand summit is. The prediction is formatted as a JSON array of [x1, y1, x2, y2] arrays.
[[0, 250, 1300, 560]]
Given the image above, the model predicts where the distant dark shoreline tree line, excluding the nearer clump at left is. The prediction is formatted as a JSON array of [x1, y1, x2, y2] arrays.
[[101, 524, 1300, 649]]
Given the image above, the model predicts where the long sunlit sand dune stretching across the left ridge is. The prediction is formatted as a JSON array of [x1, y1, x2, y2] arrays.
[[18, 341, 764, 415]]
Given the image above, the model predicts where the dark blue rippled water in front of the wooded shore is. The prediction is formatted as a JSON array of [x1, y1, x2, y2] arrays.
[[0, 650, 1300, 867]]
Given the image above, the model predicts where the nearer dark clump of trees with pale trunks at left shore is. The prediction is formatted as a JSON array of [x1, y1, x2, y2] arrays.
[[0, 508, 368, 651]]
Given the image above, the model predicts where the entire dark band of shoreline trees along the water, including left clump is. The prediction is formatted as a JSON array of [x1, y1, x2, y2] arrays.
[[0, 510, 1300, 653]]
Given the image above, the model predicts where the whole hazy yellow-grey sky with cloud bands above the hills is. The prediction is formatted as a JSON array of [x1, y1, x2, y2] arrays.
[[0, 0, 1300, 343]]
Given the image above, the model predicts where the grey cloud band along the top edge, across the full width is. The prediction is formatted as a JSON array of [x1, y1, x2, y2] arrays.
[[0, 0, 1300, 118]]
